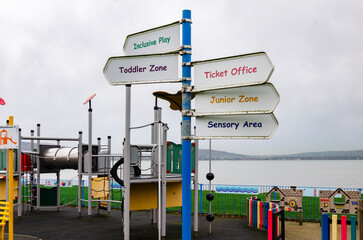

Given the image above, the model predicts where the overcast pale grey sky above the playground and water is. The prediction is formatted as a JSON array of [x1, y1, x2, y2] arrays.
[[0, 0, 363, 155]]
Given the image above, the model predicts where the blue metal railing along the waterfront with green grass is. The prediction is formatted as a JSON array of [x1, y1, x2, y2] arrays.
[[32, 179, 362, 221]]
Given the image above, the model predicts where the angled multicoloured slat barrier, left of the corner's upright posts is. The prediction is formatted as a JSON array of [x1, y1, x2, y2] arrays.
[[247, 197, 285, 240]]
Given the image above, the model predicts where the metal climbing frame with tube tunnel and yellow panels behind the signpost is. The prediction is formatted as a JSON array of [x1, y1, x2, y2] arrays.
[[0, 93, 198, 239]]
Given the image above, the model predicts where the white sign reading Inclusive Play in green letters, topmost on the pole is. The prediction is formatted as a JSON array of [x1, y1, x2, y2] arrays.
[[124, 21, 180, 56]]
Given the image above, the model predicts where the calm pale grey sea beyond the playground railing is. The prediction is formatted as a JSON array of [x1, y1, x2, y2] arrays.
[[42, 160, 363, 188]]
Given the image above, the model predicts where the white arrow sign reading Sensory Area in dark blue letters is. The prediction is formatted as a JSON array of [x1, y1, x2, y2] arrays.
[[195, 113, 278, 139]]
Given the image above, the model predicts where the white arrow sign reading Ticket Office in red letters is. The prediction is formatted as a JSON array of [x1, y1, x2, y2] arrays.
[[192, 52, 274, 91]]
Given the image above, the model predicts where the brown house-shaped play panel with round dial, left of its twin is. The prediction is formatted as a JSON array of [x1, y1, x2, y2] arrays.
[[266, 186, 304, 225]]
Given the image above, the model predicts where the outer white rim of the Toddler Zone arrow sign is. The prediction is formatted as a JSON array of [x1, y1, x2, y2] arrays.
[[103, 52, 182, 86]]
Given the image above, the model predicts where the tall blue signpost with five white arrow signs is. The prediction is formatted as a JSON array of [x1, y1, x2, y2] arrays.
[[103, 10, 280, 240]]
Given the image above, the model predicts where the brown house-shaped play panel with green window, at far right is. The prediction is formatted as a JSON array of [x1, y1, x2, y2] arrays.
[[319, 188, 360, 214]]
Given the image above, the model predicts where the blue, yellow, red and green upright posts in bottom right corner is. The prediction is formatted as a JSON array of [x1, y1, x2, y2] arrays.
[[321, 213, 357, 240]]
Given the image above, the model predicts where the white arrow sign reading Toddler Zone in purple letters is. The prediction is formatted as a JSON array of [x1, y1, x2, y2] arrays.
[[103, 53, 180, 85]]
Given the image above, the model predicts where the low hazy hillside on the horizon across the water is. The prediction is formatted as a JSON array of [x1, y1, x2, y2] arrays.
[[199, 149, 363, 160]]
